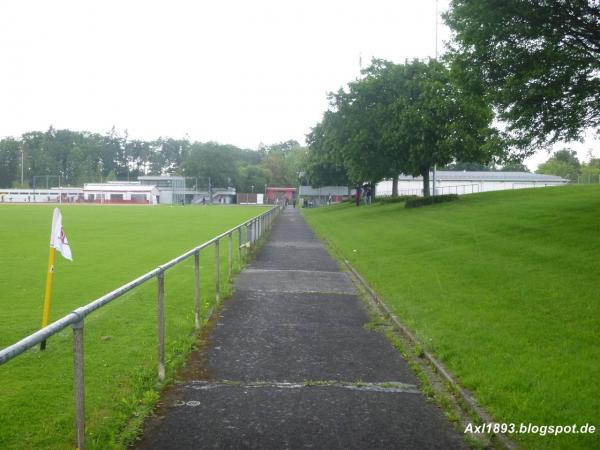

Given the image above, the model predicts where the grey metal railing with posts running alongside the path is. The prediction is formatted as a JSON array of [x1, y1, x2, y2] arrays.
[[0, 206, 281, 450]]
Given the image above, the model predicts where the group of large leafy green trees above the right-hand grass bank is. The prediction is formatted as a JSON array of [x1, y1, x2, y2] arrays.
[[306, 0, 600, 195]]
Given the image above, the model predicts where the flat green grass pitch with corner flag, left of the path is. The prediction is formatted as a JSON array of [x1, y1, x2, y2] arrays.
[[0, 205, 265, 449]]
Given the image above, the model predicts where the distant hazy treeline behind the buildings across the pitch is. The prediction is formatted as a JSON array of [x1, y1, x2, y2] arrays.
[[0, 127, 306, 192]]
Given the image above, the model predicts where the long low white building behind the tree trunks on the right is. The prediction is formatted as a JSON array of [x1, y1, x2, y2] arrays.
[[375, 170, 569, 196]]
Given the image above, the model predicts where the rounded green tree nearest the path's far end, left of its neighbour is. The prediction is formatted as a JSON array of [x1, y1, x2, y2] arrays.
[[308, 60, 407, 195]]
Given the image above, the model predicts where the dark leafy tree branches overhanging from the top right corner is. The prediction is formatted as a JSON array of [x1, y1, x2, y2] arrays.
[[444, 0, 600, 149]]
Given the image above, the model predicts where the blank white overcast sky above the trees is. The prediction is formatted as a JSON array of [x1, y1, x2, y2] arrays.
[[0, 0, 598, 171]]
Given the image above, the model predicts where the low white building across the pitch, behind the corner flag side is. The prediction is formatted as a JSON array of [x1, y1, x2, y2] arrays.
[[83, 181, 159, 205]]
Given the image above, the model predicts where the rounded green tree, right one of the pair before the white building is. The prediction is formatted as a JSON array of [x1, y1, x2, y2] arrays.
[[395, 60, 504, 196]]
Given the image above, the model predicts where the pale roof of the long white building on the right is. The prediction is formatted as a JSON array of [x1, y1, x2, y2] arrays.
[[398, 170, 569, 183]]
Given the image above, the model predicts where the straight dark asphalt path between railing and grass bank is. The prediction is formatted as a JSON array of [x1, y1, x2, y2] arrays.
[[135, 209, 465, 450]]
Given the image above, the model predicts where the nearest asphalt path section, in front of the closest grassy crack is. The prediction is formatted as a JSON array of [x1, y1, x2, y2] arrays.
[[135, 386, 465, 450]]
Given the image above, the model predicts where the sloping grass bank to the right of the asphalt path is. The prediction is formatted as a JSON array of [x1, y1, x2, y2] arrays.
[[305, 186, 600, 449]]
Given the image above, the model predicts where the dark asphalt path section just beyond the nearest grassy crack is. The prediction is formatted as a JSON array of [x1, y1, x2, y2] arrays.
[[195, 291, 418, 384]]
